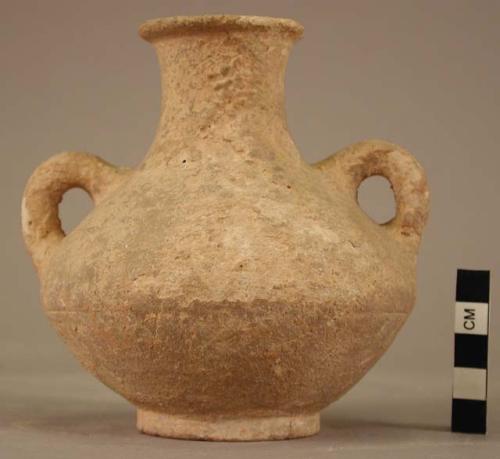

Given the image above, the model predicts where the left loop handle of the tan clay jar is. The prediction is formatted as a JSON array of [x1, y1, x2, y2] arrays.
[[22, 152, 132, 271]]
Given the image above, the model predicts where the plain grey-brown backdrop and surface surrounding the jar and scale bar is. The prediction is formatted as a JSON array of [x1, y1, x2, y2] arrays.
[[0, 0, 500, 459]]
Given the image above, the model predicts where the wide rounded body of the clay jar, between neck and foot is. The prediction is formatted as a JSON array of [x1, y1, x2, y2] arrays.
[[43, 139, 416, 417]]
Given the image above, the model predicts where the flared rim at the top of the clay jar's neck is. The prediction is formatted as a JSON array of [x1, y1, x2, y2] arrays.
[[139, 15, 304, 42]]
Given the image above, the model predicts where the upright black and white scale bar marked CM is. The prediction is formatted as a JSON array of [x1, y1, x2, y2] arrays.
[[451, 269, 490, 434]]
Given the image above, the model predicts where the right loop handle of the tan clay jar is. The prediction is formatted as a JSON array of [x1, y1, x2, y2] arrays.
[[315, 140, 429, 247]]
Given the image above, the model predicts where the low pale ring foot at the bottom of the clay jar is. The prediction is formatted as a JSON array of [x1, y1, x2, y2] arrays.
[[137, 409, 320, 441]]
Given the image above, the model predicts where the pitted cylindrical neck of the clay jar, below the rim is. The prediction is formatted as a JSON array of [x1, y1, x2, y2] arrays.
[[148, 29, 294, 162]]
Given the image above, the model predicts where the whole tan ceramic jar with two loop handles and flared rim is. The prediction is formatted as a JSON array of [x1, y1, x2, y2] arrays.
[[23, 16, 428, 440]]
